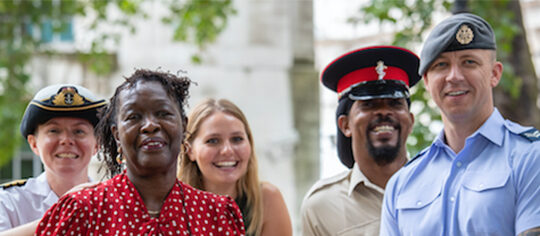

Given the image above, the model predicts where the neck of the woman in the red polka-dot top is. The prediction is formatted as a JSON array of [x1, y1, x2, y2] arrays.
[[127, 169, 176, 211]]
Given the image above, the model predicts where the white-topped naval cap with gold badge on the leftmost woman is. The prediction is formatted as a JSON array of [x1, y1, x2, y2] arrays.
[[20, 84, 107, 138]]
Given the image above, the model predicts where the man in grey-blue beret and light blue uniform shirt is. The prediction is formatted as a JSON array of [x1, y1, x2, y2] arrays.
[[381, 13, 540, 235]]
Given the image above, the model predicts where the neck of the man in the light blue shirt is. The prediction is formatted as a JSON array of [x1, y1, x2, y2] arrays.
[[442, 107, 493, 153]]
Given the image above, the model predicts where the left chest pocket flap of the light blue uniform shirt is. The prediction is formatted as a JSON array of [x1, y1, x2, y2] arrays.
[[396, 185, 441, 210]]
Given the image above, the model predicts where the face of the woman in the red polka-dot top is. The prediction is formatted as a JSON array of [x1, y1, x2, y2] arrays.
[[112, 81, 183, 176]]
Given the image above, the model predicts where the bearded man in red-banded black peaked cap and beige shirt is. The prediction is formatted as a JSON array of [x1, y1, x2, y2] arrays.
[[302, 46, 420, 235]]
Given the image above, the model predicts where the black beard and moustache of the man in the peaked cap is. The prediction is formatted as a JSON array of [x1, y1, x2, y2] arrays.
[[366, 115, 401, 166]]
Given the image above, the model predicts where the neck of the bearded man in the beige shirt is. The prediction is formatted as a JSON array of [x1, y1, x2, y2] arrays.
[[357, 152, 407, 189]]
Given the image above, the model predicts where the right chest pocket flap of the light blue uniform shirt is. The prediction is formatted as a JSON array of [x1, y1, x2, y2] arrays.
[[463, 171, 510, 192]]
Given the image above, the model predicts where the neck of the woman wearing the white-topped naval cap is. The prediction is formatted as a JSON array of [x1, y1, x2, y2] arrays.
[[45, 169, 89, 197]]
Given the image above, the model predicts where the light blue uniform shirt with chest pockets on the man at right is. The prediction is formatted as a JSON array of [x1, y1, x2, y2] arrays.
[[380, 109, 540, 235]]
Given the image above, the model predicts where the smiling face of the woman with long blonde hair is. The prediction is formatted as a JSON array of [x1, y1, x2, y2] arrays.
[[188, 111, 252, 189]]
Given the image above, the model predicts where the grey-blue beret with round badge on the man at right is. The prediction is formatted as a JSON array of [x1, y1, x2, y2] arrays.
[[418, 13, 497, 75]]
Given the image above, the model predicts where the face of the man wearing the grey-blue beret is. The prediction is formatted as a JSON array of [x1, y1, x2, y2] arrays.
[[424, 49, 502, 124]]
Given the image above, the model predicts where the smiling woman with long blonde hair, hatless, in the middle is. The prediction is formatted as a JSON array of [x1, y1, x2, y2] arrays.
[[179, 99, 292, 236]]
